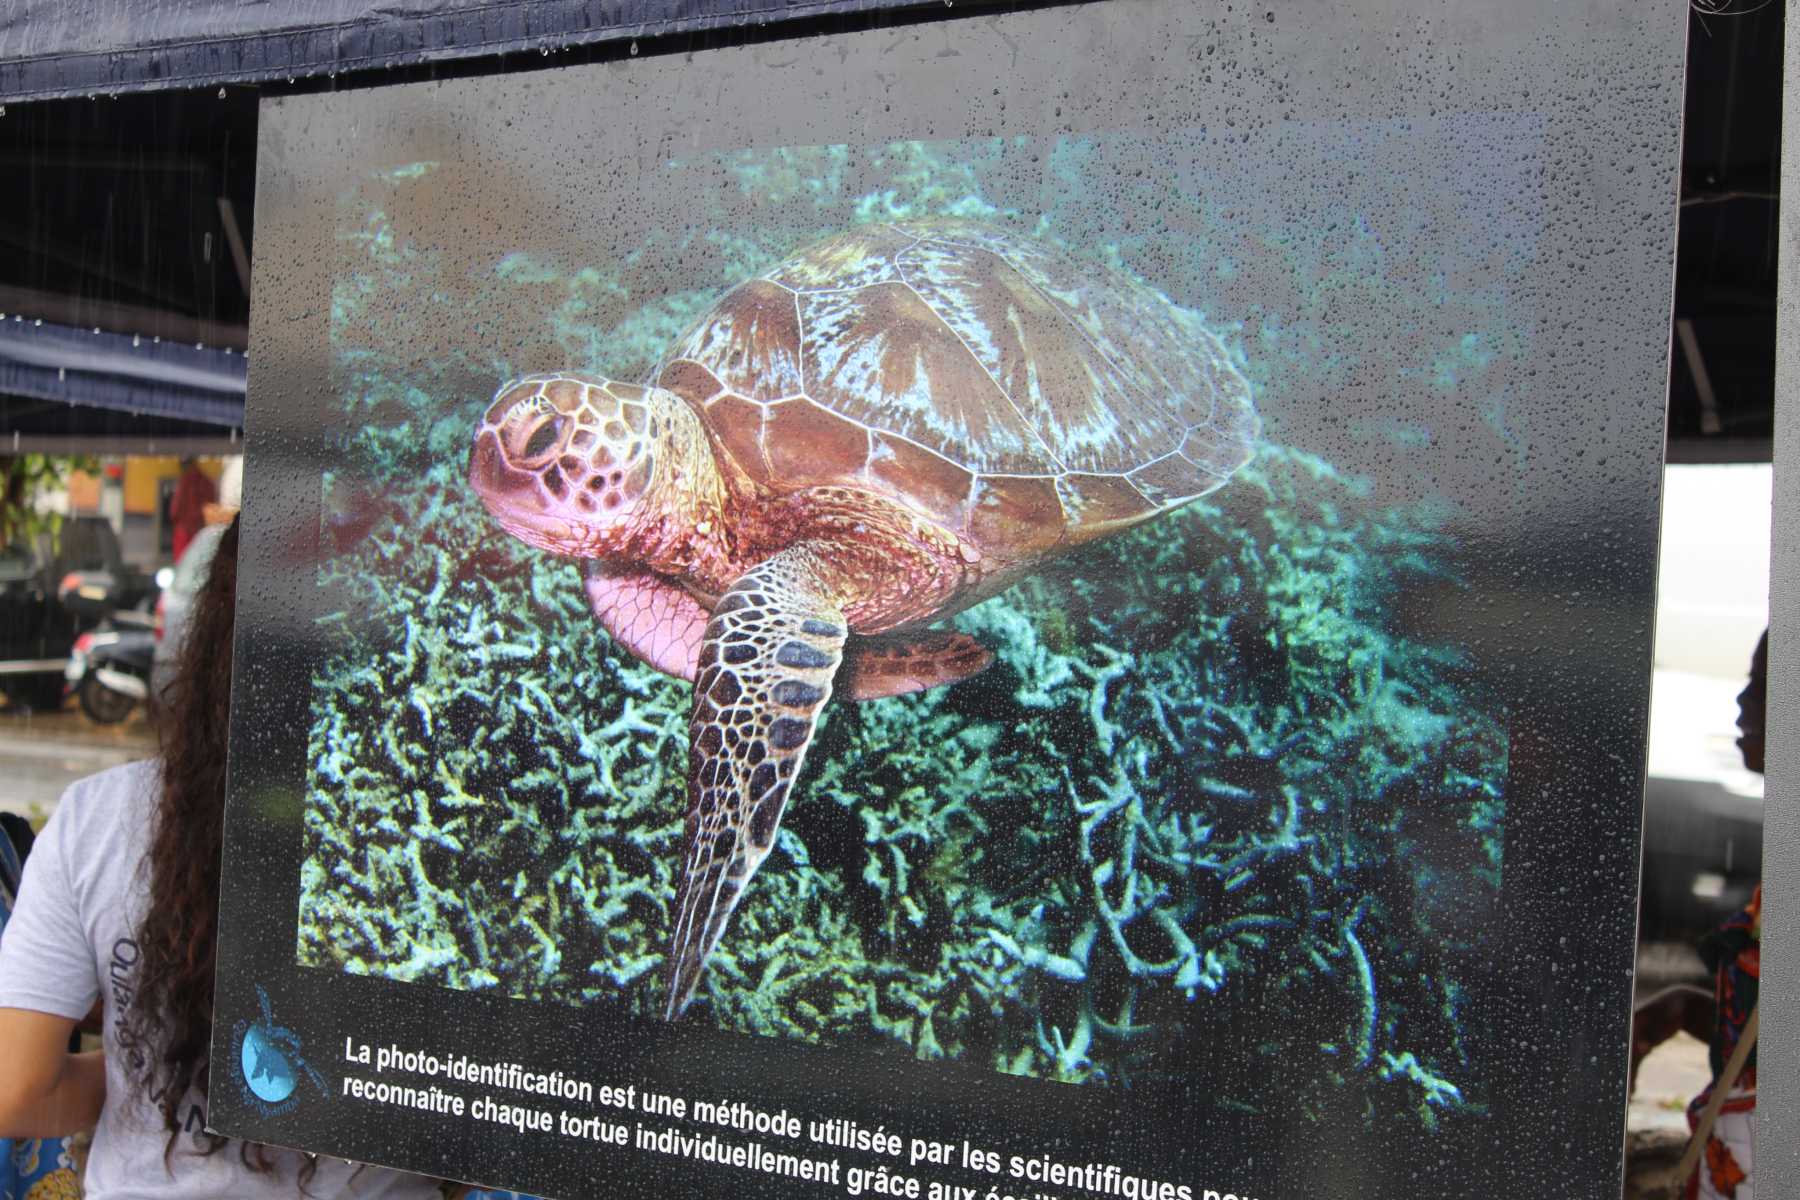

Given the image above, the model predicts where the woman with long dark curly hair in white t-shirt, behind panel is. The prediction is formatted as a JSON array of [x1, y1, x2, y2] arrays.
[[0, 522, 441, 1200]]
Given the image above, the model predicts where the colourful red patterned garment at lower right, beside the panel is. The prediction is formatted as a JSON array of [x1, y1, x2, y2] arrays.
[[1687, 887, 1762, 1200]]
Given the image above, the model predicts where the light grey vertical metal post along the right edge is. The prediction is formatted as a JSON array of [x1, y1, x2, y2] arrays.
[[1755, 0, 1800, 1196]]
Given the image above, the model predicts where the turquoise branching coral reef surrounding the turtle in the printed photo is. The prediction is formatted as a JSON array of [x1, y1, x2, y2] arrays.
[[297, 135, 1507, 1126]]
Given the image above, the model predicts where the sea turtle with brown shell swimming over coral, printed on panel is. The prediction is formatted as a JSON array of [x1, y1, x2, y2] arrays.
[[470, 221, 1258, 1020]]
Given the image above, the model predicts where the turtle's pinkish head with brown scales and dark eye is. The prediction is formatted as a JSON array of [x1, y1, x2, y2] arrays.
[[468, 374, 680, 558]]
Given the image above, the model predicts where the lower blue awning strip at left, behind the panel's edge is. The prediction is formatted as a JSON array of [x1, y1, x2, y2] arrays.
[[0, 317, 248, 428]]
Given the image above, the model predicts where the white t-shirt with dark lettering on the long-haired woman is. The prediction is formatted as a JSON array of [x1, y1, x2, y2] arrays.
[[0, 763, 439, 1200]]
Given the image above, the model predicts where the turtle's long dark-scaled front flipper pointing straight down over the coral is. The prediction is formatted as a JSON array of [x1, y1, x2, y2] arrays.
[[666, 545, 846, 1020]]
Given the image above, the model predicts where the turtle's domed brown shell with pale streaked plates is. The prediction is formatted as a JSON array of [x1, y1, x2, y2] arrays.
[[655, 221, 1258, 558]]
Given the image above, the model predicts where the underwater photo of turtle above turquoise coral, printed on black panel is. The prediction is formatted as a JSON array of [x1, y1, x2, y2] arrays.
[[293, 134, 1504, 1124]]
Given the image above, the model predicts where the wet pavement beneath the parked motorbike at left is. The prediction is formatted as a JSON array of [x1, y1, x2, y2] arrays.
[[0, 703, 157, 824]]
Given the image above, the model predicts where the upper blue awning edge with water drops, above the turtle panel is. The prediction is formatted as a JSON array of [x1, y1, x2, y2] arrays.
[[0, 0, 943, 103]]
